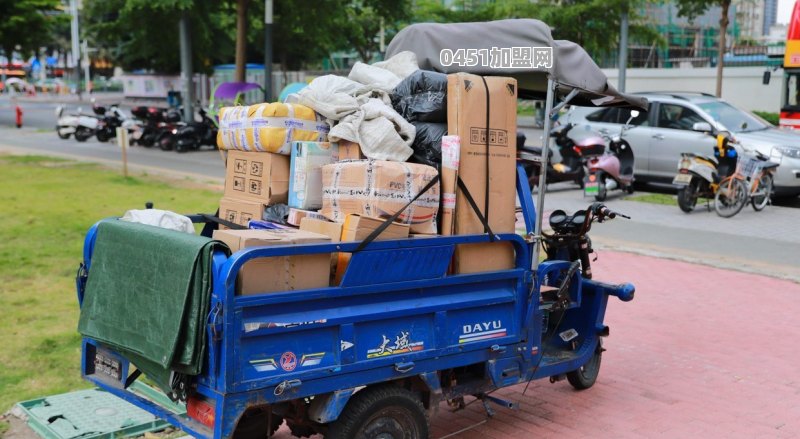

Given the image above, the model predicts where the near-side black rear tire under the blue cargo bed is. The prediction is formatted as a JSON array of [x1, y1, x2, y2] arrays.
[[325, 385, 430, 439]]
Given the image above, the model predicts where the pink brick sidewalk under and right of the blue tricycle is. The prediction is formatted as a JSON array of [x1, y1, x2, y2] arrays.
[[275, 251, 800, 439]]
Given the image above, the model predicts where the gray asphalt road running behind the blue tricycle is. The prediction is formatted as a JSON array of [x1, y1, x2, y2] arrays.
[[0, 119, 800, 281]]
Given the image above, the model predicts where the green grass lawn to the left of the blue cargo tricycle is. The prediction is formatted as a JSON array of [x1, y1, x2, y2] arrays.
[[0, 155, 221, 412]]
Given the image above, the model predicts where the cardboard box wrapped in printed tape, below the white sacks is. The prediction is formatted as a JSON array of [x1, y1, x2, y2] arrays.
[[320, 160, 440, 233]]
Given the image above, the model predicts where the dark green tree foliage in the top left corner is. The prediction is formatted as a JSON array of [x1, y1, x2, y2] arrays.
[[0, 0, 68, 57]]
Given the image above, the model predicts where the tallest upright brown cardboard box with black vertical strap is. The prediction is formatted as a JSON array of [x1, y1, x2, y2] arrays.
[[447, 73, 517, 273]]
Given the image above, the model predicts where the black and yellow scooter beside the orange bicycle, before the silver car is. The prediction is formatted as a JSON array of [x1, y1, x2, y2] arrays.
[[672, 127, 739, 213]]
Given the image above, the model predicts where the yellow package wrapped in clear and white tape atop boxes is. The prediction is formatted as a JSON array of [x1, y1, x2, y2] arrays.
[[217, 102, 330, 155]]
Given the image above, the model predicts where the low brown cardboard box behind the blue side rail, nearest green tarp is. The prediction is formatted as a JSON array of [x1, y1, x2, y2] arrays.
[[214, 229, 330, 296]]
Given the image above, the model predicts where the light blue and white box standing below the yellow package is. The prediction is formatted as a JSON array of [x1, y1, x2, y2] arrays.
[[289, 142, 339, 210]]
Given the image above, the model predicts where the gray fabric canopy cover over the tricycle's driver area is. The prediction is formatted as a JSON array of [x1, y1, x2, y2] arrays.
[[386, 19, 647, 109]]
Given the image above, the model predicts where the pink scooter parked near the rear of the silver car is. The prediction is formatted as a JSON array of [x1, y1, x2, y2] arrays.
[[583, 110, 639, 201]]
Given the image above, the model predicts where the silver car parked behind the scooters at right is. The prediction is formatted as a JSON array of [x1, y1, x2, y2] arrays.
[[561, 93, 800, 196]]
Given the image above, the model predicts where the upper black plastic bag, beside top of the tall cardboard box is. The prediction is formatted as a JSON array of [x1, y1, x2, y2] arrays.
[[392, 70, 447, 123]]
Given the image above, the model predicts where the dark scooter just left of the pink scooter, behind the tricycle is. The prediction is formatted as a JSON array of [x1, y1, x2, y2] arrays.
[[525, 123, 605, 190]]
